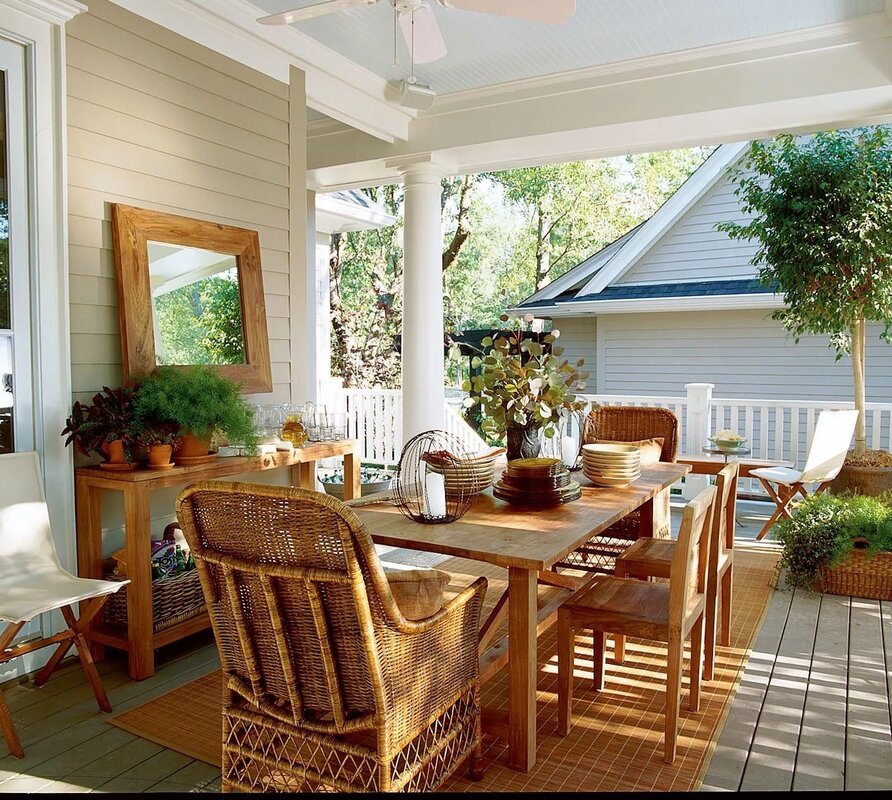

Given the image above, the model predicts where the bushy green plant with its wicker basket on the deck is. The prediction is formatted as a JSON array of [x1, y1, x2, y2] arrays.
[[772, 492, 892, 600]]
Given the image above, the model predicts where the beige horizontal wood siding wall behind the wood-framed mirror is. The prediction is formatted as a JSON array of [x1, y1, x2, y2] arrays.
[[66, 0, 292, 403]]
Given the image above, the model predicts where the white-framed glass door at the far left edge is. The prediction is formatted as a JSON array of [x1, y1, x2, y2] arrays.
[[0, 39, 34, 454]]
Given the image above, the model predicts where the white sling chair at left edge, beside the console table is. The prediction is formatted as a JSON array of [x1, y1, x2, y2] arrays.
[[0, 452, 129, 758]]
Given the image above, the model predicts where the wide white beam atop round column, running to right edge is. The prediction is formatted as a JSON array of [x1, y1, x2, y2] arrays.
[[308, 20, 892, 190]]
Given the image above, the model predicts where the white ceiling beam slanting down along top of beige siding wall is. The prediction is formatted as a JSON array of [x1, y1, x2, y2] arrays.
[[112, 0, 414, 143]]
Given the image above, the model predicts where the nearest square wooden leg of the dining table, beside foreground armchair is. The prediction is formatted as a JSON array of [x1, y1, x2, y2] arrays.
[[508, 567, 538, 772]]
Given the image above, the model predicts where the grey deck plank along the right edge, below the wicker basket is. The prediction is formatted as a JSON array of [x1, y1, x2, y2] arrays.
[[845, 599, 892, 792]]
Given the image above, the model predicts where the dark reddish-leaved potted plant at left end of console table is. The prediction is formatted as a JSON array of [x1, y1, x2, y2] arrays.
[[62, 386, 139, 469]]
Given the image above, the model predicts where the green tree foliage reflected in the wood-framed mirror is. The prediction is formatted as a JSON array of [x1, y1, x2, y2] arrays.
[[154, 269, 245, 364]]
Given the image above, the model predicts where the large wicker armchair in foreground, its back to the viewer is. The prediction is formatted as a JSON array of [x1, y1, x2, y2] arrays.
[[177, 481, 486, 792]]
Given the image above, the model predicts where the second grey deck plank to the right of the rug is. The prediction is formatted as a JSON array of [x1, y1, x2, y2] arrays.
[[740, 592, 820, 791]]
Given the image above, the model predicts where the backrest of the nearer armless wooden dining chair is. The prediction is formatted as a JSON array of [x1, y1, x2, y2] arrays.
[[669, 486, 716, 628]]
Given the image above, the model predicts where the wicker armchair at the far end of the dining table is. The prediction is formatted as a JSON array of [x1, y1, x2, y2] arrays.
[[556, 406, 678, 575]]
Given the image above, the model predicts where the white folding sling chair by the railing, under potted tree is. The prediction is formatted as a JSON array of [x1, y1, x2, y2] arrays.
[[750, 409, 858, 539]]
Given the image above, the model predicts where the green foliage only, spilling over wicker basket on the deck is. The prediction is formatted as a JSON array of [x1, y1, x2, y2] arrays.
[[772, 492, 892, 589]]
